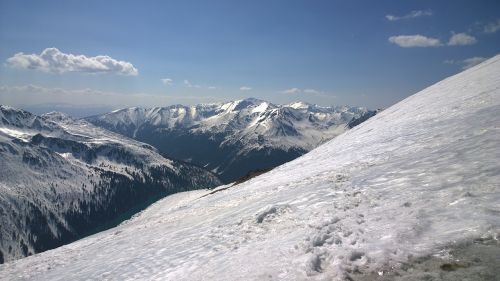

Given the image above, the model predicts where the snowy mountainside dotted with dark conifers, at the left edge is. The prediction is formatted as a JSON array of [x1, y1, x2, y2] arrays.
[[0, 106, 220, 262]]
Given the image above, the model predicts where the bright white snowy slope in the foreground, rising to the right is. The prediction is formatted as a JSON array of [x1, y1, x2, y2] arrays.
[[0, 56, 500, 280]]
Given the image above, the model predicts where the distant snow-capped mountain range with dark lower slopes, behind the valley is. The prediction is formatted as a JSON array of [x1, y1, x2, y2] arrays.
[[86, 98, 367, 182]]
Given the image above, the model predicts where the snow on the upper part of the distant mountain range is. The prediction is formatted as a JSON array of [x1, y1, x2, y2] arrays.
[[87, 98, 367, 156]]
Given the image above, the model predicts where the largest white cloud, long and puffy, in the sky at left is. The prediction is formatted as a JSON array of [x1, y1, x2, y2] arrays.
[[7, 48, 139, 76]]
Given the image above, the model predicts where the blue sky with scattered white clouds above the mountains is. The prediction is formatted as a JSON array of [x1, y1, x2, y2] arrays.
[[0, 0, 500, 115]]
